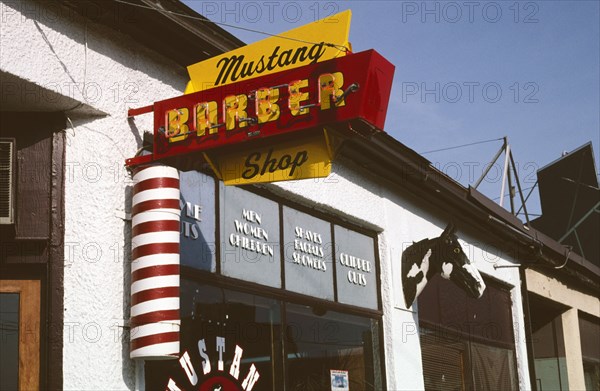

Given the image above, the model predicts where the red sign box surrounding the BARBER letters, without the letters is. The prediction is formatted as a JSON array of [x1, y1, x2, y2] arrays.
[[126, 50, 394, 166]]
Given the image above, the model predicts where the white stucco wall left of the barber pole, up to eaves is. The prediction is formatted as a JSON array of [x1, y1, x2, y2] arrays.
[[0, 1, 187, 390]]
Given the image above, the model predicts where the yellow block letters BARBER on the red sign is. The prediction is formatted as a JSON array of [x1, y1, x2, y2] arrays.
[[164, 71, 346, 143]]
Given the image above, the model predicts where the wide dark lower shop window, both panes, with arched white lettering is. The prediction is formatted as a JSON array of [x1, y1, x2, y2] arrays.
[[145, 279, 382, 390]]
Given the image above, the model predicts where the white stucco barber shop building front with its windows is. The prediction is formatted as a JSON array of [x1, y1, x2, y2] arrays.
[[0, 0, 600, 390]]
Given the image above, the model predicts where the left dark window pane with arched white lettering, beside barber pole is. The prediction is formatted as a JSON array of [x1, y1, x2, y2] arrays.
[[146, 280, 282, 390]]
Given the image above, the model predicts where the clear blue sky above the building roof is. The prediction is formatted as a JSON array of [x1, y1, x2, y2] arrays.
[[184, 0, 600, 217]]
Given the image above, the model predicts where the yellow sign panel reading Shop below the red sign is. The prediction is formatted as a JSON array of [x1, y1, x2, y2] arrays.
[[205, 135, 331, 185]]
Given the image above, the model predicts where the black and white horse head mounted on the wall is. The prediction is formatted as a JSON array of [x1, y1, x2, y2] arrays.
[[402, 223, 485, 308]]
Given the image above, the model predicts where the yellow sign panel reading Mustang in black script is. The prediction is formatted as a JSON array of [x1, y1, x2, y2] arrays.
[[185, 10, 352, 94]]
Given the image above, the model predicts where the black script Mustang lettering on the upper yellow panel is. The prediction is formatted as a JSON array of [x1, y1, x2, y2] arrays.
[[215, 42, 326, 86]]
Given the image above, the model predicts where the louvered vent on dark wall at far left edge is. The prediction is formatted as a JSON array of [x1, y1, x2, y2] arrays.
[[0, 138, 16, 224]]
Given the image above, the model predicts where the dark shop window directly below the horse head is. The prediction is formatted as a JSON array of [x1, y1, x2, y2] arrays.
[[419, 276, 517, 390]]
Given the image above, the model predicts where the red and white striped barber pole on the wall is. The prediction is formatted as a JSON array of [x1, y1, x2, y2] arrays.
[[130, 165, 181, 360]]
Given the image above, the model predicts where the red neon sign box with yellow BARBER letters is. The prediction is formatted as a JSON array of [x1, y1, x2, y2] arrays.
[[127, 50, 394, 170]]
